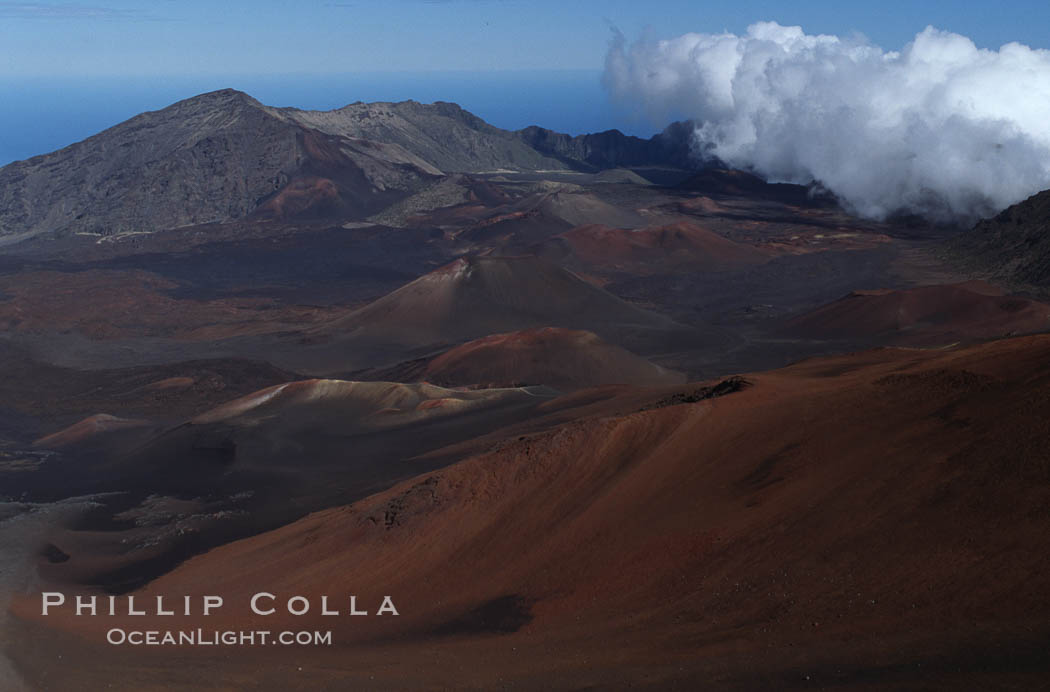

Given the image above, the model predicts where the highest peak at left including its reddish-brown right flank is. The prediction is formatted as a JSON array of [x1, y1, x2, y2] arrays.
[[0, 89, 441, 243]]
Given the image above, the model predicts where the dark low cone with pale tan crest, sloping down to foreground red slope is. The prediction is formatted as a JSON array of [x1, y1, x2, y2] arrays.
[[14, 380, 557, 592]]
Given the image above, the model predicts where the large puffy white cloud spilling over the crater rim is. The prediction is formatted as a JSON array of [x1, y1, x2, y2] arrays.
[[605, 22, 1050, 221]]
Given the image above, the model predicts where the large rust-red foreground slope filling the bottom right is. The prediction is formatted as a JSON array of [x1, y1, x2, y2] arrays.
[[14, 336, 1050, 690]]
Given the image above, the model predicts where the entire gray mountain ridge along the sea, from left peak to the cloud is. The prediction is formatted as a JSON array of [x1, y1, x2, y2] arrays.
[[0, 89, 688, 245]]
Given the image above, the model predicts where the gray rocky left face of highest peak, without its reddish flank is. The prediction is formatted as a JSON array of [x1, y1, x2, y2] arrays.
[[0, 91, 310, 237]]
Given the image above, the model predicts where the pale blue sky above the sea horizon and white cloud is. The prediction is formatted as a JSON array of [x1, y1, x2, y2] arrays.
[[0, 0, 1050, 77]]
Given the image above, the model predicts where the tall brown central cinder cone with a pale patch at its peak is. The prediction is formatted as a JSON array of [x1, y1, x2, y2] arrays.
[[311, 256, 681, 370]]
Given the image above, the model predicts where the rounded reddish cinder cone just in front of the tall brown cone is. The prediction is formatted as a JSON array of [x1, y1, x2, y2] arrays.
[[422, 327, 685, 392]]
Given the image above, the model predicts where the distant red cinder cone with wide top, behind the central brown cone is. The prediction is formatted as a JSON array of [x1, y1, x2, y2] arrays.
[[554, 222, 770, 273]]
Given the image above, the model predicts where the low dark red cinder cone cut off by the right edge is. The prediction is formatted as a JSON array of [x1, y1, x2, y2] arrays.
[[788, 281, 1050, 345]]
